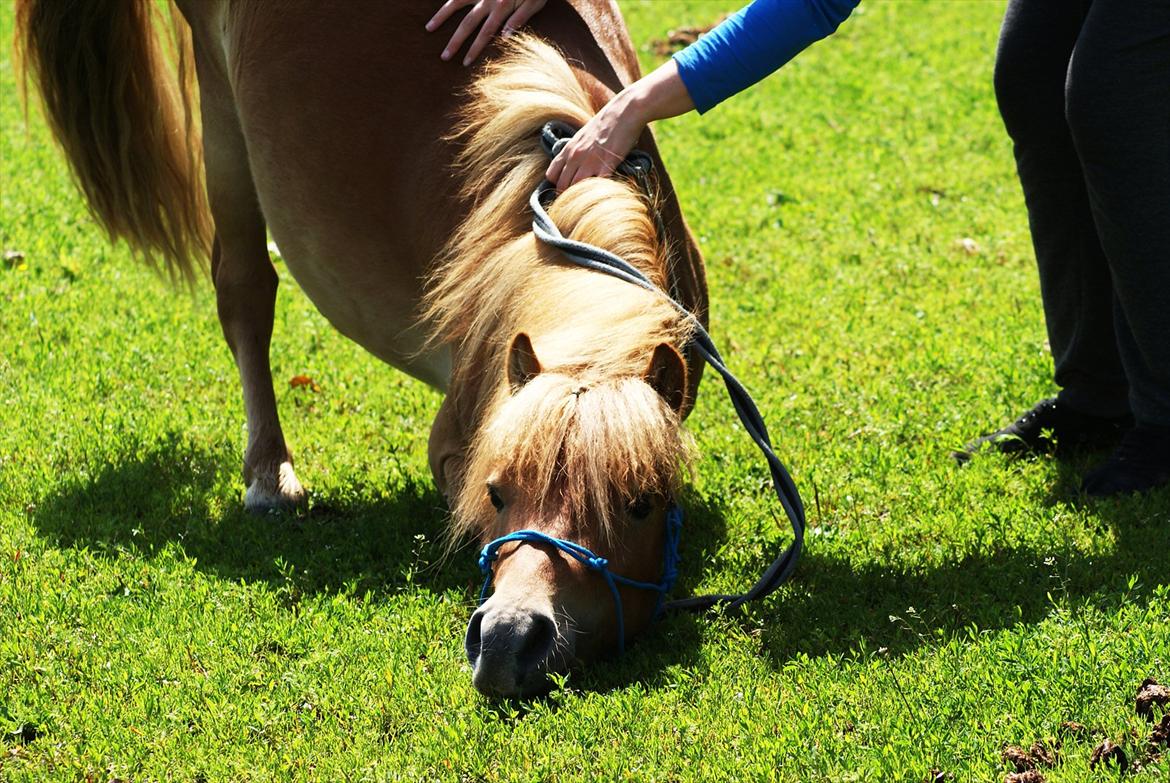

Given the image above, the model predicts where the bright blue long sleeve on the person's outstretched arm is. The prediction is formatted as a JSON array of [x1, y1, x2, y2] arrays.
[[674, 0, 860, 114]]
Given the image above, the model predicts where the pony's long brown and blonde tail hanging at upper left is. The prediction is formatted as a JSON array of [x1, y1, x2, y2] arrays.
[[16, 0, 212, 281]]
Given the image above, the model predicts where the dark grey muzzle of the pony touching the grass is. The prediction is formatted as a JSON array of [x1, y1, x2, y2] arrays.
[[463, 605, 557, 696]]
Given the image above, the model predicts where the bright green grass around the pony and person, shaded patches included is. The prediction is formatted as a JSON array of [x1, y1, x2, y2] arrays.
[[0, 0, 1170, 782]]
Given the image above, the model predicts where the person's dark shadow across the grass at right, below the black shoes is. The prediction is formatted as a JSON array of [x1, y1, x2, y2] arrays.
[[757, 451, 1170, 666]]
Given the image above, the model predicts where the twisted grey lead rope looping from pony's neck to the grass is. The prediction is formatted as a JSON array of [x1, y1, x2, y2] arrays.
[[529, 122, 805, 611]]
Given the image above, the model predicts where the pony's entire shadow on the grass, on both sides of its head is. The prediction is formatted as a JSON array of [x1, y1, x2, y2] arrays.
[[28, 433, 727, 689]]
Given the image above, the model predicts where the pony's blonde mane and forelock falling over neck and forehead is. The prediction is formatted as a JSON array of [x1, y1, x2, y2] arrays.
[[424, 36, 690, 537]]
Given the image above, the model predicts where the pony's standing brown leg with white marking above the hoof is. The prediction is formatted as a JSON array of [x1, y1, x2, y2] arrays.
[[197, 62, 304, 511]]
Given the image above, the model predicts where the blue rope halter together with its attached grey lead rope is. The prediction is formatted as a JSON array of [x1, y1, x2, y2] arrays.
[[480, 122, 805, 652]]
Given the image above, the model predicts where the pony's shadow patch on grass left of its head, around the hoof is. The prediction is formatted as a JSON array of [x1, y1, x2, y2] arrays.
[[32, 434, 476, 602]]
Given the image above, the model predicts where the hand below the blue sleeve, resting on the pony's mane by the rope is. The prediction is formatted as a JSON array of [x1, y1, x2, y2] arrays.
[[544, 94, 646, 192]]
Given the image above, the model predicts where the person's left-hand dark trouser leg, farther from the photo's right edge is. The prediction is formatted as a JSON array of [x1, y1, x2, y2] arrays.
[[996, 0, 1127, 417]]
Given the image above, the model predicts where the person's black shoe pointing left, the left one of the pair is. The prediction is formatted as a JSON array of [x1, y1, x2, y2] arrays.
[[954, 397, 1134, 462]]
